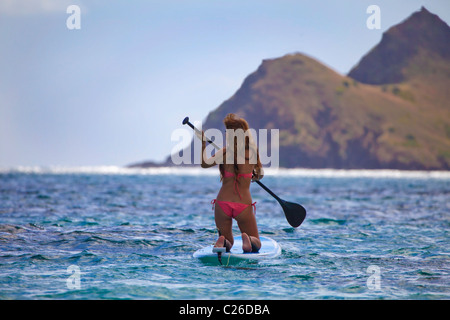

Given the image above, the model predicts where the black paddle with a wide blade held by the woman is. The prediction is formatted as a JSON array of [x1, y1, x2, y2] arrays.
[[183, 117, 306, 228]]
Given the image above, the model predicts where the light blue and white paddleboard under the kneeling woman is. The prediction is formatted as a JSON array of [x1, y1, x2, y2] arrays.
[[194, 236, 281, 266]]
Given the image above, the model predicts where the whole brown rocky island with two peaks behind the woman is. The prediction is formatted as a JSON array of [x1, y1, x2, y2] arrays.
[[130, 8, 450, 170]]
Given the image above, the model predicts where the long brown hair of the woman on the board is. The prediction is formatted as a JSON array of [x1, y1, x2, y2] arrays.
[[219, 113, 262, 180]]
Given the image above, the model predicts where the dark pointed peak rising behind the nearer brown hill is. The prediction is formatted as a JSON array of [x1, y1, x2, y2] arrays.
[[348, 7, 450, 84]]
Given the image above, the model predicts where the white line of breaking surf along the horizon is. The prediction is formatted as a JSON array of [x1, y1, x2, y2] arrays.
[[0, 166, 450, 179]]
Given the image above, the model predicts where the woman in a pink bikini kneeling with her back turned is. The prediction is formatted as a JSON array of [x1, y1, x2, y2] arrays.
[[201, 113, 263, 252]]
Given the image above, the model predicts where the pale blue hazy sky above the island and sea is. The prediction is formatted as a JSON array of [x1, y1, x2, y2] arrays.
[[0, 0, 450, 167]]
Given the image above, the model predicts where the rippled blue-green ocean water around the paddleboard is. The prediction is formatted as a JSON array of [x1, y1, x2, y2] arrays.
[[0, 167, 450, 300]]
